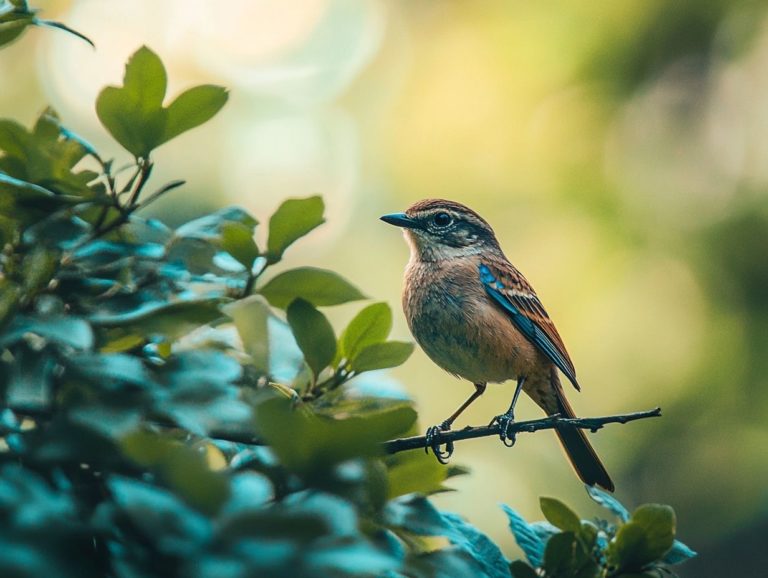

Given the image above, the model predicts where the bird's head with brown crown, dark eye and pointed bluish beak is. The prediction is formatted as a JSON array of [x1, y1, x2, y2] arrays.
[[381, 199, 498, 261]]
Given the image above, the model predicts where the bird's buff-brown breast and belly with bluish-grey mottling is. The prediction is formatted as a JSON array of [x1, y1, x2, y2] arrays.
[[403, 259, 539, 383]]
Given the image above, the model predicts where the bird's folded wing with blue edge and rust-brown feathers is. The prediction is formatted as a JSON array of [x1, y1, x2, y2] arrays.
[[480, 263, 581, 390]]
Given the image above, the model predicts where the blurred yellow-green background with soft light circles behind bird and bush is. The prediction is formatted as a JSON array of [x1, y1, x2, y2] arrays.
[[0, 0, 768, 578]]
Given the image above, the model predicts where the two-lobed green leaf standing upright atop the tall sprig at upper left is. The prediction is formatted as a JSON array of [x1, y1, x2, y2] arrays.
[[96, 46, 167, 157]]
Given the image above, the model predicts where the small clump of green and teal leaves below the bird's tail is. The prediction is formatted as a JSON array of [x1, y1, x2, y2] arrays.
[[504, 487, 696, 578]]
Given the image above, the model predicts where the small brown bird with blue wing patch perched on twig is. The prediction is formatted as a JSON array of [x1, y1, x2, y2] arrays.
[[381, 199, 614, 492]]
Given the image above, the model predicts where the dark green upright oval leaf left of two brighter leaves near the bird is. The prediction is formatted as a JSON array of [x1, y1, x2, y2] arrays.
[[286, 299, 336, 378]]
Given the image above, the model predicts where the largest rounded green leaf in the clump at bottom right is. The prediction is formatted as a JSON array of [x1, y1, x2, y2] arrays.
[[608, 504, 675, 570]]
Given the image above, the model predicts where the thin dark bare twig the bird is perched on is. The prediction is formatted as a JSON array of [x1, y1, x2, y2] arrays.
[[384, 407, 661, 454]]
